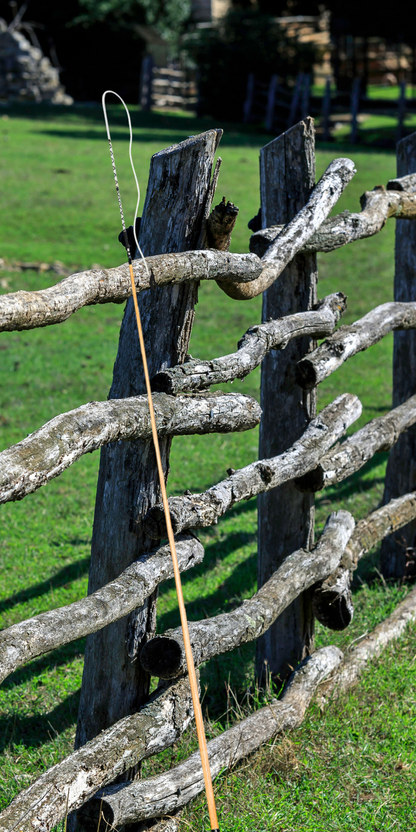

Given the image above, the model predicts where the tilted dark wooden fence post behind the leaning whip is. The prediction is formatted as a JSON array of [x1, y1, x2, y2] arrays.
[[76, 130, 221, 747]]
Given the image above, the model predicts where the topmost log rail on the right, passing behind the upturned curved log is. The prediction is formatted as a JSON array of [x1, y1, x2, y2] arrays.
[[250, 184, 416, 257]]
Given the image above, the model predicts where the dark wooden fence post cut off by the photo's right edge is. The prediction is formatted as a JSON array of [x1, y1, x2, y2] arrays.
[[381, 133, 416, 578]]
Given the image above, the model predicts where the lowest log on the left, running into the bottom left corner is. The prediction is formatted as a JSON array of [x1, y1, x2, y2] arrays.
[[0, 678, 193, 832]]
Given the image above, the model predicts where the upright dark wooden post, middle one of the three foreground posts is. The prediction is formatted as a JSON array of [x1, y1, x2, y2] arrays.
[[257, 118, 317, 679]]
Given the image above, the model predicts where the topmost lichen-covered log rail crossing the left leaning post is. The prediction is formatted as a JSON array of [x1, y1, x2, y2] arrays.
[[0, 250, 263, 332]]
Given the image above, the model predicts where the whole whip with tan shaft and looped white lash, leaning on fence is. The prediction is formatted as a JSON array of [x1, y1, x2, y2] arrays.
[[102, 90, 219, 832]]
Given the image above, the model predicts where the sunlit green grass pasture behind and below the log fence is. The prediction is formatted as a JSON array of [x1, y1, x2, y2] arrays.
[[0, 107, 416, 832]]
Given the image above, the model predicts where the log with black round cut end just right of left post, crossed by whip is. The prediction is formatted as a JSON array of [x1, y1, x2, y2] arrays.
[[140, 511, 355, 679]]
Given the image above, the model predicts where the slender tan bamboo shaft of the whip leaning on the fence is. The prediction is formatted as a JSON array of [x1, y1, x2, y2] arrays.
[[129, 262, 219, 832]]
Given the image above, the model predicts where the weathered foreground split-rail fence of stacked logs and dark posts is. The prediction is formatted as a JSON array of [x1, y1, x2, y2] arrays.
[[0, 118, 416, 832]]
